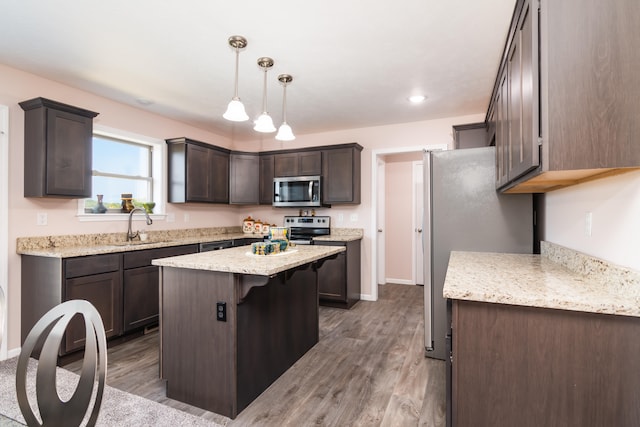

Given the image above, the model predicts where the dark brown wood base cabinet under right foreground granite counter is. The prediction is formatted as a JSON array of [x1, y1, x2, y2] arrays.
[[451, 300, 640, 427]]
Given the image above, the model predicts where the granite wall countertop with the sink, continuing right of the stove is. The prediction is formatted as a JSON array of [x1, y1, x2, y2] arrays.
[[16, 227, 363, 258]]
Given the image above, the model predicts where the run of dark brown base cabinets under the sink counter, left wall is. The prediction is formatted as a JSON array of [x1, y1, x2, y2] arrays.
[[21, 245, 198, 355]]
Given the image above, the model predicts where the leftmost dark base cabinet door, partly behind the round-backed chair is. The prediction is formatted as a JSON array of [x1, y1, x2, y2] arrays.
[[64, 271, 122, 352]]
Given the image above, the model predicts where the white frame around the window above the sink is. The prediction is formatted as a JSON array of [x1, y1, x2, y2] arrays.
[[77, 124, 167, 221]]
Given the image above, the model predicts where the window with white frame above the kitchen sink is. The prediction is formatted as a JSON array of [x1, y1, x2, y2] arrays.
[[78, 129, 164, 219]]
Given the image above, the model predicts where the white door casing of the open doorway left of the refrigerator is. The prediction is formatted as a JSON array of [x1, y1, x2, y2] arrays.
[[369, 143, 449, 301]]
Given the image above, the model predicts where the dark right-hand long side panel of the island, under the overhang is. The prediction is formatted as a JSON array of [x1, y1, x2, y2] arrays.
[[237, 263, 319, 412]]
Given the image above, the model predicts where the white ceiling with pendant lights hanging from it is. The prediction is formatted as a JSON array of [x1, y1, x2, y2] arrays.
[[0, 0, 515, 144]]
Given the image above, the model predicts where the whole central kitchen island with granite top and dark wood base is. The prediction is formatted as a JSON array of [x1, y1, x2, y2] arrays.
[[153, 245, 345, 418]]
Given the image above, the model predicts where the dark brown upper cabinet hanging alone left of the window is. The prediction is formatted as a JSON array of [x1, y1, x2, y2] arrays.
[[19, 98, 98, 199]]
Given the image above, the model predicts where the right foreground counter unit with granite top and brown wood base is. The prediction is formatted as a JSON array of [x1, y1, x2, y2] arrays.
[[443, 242, 640, 426]]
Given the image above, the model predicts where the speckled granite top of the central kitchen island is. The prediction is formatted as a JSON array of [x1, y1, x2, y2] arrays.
[[152, 245, 346, 276]]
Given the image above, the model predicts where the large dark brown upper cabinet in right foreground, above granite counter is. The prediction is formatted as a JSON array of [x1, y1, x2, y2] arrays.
[[487, 0, 640, 193]]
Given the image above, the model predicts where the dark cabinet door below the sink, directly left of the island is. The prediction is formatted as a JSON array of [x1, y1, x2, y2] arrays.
[[123, 266, 160, 332]]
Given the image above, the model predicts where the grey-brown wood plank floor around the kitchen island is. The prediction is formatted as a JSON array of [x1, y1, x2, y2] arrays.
[[65, 285, 446, 426]]
